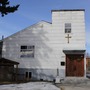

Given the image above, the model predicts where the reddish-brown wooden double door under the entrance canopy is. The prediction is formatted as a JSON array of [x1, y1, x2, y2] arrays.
[[66, 54, 84, 77]]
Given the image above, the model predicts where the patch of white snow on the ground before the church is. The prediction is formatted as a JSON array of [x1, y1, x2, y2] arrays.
[[0, 82, 60, 90]]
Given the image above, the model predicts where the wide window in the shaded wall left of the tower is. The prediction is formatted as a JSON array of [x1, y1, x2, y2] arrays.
[[20, 46, 35, 58]]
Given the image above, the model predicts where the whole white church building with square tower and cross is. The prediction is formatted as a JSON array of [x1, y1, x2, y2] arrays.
[[2, 9, 86, 81]]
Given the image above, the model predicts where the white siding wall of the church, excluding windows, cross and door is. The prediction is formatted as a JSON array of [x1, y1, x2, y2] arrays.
[[3, 11, 85, 80]]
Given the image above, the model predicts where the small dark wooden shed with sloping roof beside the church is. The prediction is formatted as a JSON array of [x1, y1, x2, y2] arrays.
[[0, 58, 19, 81]]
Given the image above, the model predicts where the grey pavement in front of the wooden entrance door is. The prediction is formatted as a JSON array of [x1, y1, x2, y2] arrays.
[[56, 78, 90, 90]]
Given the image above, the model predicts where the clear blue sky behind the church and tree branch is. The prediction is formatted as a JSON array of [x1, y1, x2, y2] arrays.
[[0, 0, 90, 53]]
